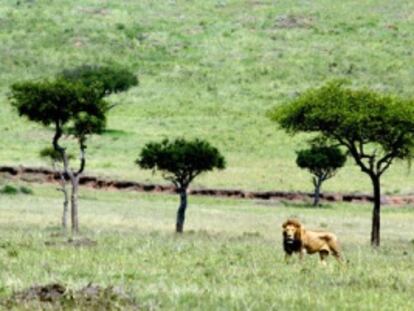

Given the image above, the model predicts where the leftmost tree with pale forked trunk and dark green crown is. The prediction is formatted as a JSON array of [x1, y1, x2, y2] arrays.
[[10, 79, 108, 233]]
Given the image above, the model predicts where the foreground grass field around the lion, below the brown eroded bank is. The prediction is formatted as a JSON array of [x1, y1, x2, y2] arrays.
[[0, 186, 414, 310]]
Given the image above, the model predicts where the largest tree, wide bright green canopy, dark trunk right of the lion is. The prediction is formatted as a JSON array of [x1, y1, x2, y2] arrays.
[[270, 81, 414, 246]]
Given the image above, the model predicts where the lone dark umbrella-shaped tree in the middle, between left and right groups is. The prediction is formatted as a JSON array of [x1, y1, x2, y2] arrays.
[[136, 139, 225, 233]]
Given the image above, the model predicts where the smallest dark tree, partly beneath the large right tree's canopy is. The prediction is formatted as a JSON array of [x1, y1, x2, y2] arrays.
[[296, 145, 346, 206]]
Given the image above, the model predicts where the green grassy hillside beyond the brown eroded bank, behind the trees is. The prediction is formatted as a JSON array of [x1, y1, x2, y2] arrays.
[[0, 0, 414, 193]]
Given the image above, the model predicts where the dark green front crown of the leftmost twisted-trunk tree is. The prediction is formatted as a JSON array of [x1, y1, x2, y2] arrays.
[[10, 78, 108, 139]]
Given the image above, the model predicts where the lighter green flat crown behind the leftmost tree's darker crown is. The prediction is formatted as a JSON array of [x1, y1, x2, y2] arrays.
[[60, 65, 139, 95]]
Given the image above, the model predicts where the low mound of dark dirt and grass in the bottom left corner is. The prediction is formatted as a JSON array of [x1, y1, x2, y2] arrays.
[[3, 283, 139, 310]]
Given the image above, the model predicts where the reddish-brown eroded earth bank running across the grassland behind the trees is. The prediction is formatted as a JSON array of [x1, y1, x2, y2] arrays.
[[0, 166, 414, 205]]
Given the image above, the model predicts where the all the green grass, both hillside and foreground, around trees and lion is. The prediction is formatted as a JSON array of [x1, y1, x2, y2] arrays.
[[0, 0, 414, 310]]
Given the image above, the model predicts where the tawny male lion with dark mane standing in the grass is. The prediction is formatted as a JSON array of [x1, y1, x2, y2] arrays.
[[282, 219, 342, 265]]
